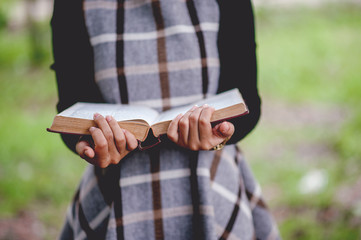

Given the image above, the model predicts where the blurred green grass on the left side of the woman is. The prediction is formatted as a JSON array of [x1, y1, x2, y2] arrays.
[[0, 15, 85, 239]]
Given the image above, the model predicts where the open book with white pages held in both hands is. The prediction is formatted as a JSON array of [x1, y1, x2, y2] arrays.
[[47, 89, 248, 142]]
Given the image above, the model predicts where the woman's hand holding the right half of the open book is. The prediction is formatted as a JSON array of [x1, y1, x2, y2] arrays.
[[167, 105, 234, 151]]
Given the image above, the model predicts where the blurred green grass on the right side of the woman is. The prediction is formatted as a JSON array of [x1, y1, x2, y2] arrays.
[[240, 4, 361, 239]]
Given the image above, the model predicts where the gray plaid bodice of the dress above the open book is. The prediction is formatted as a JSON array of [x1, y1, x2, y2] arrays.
[[83, 0, 219, 110]]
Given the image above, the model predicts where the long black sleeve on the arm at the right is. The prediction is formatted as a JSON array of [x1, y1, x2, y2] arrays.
[[218, 0, 261, 144]]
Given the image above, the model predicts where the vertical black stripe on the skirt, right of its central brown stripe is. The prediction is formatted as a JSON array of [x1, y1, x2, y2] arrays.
[[189, 152, 204, 239]]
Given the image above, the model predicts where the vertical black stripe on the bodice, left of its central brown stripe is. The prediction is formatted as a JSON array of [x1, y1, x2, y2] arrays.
[[116, 0, 129, 104]]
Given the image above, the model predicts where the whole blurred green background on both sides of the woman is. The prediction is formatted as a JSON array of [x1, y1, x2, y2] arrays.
[[0, 0, 361, 240]]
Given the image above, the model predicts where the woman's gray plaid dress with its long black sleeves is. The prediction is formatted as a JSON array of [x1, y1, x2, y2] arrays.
[[52, 0, 279, 239]]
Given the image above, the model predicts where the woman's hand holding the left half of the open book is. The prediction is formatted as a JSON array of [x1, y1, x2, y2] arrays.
[[75, 113, 138, 168]]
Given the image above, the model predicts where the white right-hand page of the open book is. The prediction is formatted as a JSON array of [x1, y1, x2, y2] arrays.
[[155, 89, 244, 122]]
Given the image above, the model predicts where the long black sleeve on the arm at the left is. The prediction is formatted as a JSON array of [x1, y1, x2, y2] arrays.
[[51, 0, 102, 151]]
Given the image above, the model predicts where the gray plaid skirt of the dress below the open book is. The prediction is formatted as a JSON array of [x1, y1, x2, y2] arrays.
[[61, 145, 279, 239]]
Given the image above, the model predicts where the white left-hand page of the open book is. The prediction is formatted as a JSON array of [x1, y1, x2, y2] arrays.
[[58, 103, 158, 124]]
